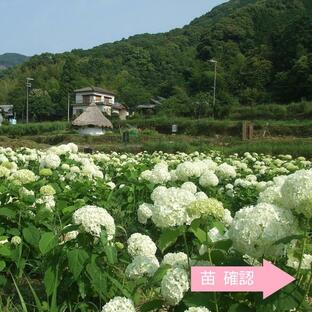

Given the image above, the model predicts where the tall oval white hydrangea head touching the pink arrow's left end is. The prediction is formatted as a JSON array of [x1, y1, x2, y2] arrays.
[[160, 267, 189, 306]]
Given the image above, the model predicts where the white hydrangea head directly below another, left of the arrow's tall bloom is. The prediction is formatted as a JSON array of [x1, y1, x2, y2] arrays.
[[125, 256, 159, 279]]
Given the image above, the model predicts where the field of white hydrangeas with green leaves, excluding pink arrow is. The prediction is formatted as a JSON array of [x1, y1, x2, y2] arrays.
[[0, 143, 312, 312]]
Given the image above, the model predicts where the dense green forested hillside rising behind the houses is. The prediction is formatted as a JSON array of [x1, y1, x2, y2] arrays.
[[0, 0, 312, 119]]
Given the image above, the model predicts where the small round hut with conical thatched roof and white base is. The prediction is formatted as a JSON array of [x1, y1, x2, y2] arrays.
[[72, 102, 113, 136]]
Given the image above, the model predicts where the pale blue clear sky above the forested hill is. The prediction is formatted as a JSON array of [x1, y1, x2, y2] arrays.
[[0, 0, 226, 55]]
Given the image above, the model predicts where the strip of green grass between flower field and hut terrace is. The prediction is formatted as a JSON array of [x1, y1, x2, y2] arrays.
[[0, 132, 312, 158]]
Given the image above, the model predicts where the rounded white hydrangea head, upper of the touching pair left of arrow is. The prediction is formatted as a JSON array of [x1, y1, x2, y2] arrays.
[[127, 233, 157, 257]]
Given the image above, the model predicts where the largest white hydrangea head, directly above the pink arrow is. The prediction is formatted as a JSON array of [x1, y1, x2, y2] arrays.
[[228, 203, 299, 258]]
